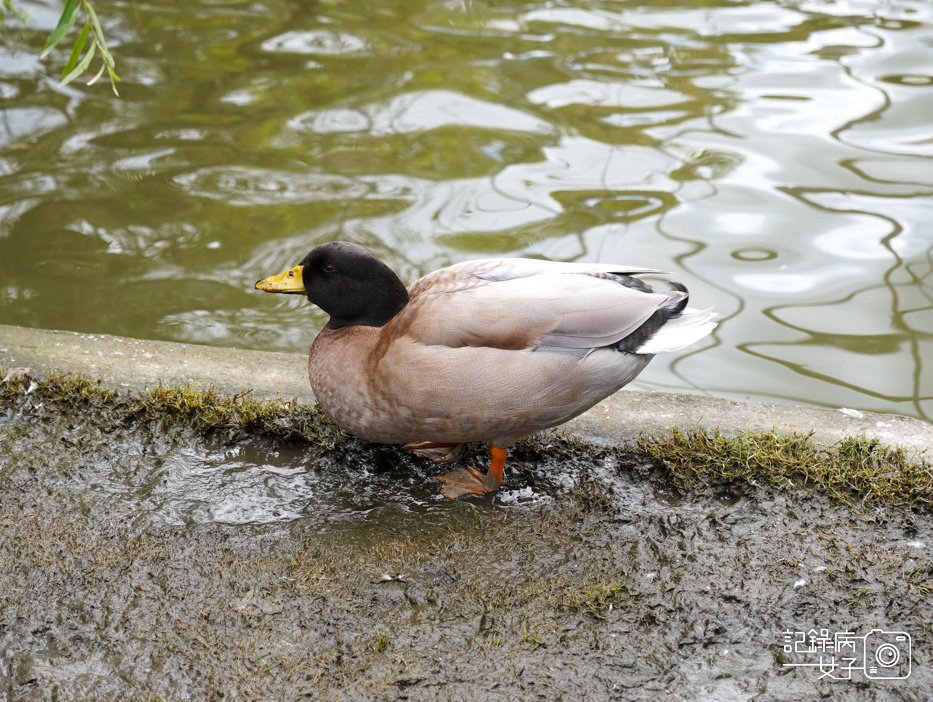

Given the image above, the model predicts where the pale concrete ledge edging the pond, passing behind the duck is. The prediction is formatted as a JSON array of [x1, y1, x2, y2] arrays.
[[0, 325, 933, 455]]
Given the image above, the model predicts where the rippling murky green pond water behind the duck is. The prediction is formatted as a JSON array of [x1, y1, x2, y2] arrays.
[[0, 0, 933, 418]]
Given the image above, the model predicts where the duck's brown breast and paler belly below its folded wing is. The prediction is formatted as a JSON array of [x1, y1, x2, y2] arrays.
[[309, 327, 647, 445]]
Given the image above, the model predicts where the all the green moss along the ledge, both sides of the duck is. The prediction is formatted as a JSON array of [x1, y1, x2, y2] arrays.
[[0, 368, 933, 511]]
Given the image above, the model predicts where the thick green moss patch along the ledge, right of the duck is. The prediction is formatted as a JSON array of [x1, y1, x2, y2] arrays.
[[637, 429, 933, 510]]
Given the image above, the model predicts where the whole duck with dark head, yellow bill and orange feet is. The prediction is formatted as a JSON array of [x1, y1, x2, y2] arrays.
[[256, 241, 716, 499]]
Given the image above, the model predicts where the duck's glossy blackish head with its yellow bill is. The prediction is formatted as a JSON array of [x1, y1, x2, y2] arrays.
[[256, 241, 408, 329]]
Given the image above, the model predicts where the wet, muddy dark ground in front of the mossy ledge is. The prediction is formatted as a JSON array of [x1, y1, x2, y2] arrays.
[[0, 382, 933, 700]]
